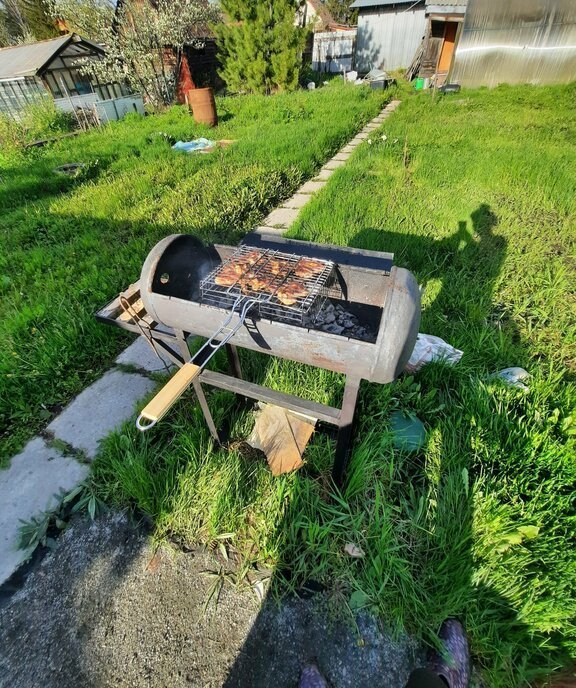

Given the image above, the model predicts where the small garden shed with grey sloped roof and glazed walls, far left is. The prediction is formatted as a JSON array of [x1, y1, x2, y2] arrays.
[[0, 34, 141, 119]]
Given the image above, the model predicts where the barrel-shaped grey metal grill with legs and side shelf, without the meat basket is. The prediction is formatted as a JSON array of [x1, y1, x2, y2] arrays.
[[96, 235, 420, 484]]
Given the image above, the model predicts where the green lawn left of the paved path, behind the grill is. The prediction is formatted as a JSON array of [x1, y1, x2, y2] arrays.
[[0, 83, 390, 465]]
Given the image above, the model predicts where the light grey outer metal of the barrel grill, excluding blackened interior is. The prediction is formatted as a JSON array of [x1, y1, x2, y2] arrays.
[[141, 236, 420, 384]]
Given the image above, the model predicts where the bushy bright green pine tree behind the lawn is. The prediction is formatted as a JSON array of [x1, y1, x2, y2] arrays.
[[215, 0, 306, 93]]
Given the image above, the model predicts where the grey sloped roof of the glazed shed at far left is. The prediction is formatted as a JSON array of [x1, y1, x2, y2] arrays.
[[0, 33, 103, 80]]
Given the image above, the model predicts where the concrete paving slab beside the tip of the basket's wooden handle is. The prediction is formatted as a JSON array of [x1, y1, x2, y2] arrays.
[[47, 370, 156, 458]]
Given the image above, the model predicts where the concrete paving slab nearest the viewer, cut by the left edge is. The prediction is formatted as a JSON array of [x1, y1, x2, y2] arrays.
[[0, 437, 89, 585]]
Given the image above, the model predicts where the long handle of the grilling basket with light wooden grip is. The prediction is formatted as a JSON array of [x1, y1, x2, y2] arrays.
[[136, 298, 256, 432]]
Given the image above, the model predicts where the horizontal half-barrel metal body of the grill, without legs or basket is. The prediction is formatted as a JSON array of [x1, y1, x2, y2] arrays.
[[140, 235, 420, 384]]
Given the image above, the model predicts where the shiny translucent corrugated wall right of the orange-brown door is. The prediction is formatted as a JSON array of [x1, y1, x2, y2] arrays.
[[450, 0, 576, 86]]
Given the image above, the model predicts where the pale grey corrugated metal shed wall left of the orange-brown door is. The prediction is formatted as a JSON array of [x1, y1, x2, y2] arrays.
[[354, 0, 428, 72]]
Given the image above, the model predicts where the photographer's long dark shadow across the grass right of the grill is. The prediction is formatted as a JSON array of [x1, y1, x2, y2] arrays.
[[219, 204, 569, 688]]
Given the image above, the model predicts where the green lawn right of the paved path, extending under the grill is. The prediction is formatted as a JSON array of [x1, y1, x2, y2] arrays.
[[95, 86, 576, 687]]
